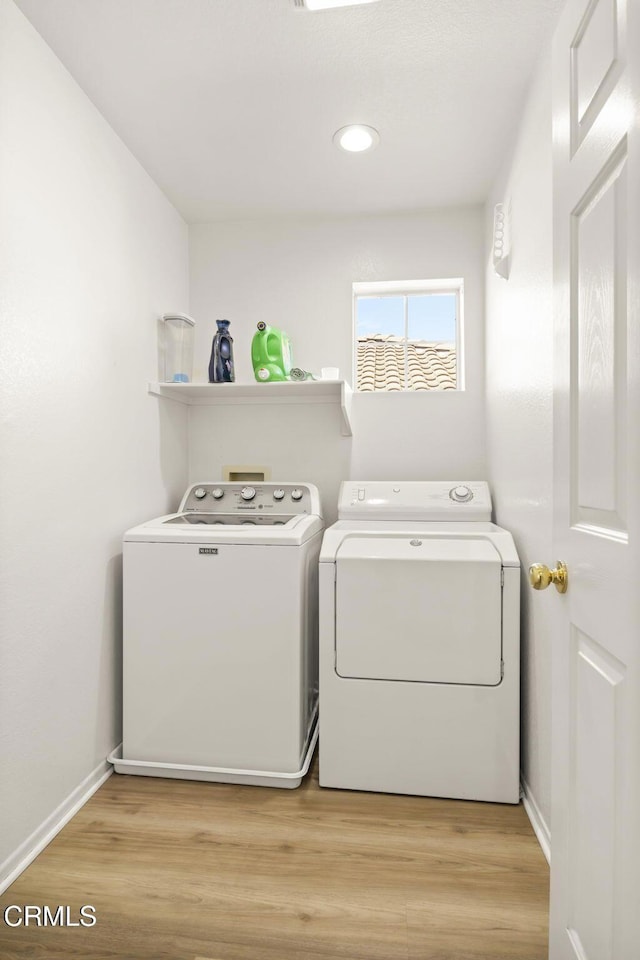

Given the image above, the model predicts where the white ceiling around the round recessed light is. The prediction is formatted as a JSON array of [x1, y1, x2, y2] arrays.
[[16, 0, 563, 222]]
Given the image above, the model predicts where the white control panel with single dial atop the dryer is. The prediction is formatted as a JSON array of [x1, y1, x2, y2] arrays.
[[338, 480, 491, 523]]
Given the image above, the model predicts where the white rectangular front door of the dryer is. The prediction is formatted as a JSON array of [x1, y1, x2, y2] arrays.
[[336, 535, 502, 686]]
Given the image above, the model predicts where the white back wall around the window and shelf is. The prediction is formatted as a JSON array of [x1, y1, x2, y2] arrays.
[[190, 207, 485, 516]]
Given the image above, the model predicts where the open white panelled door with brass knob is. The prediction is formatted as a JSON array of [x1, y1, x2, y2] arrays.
[[552, 0, 640, 960]]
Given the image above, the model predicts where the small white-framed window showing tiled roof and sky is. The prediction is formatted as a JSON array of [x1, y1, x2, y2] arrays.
[[353, 279, 463, 392]]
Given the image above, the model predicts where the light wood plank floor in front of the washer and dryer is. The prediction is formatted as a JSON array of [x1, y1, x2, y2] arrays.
[[0, 766, 549, 960]]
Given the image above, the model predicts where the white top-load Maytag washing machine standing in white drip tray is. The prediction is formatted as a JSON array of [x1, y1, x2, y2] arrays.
[[110, 482, 324, 787]]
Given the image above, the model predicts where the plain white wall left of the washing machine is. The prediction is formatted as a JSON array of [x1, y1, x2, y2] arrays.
[[0, 0, 188, 884]]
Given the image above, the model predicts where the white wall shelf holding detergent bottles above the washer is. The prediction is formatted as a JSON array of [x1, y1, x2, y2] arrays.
[[148, 380, 352, 437]]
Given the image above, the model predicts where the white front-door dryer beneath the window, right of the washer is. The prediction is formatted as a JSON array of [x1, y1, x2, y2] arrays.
[[320, 481, 520, 803]]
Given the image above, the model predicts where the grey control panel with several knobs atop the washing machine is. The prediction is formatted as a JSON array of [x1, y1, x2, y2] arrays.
[[178, 481, 321, 516]]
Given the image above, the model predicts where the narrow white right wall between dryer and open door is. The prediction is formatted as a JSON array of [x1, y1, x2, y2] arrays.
[[486, 50, 556, 840]]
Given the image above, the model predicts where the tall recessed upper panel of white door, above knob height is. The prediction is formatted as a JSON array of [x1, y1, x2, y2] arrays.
[[569, 136, 628, 540]]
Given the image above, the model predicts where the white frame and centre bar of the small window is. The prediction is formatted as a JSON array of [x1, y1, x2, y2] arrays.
[[351, 277, 465, 397]]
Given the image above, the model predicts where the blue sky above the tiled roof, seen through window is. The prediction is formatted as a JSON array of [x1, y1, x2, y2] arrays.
[[356, 293, 457, 343]]
